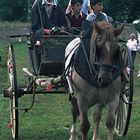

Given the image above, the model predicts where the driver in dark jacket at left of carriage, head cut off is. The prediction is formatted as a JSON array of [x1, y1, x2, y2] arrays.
[[31, 0, 67, 43]]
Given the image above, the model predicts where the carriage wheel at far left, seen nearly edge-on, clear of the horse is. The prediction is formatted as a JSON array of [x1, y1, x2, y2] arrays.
[[7, 46, 19, 140]]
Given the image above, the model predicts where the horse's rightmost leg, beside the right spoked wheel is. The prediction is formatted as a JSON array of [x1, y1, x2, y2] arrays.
[[106, 96, 119, 140]]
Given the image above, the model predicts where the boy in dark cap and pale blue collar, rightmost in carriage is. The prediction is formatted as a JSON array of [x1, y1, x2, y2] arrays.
[[81, 0, 115, 52]]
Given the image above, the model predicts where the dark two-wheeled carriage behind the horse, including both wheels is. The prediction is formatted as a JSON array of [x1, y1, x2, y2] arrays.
[[4, 24, 133, 139]]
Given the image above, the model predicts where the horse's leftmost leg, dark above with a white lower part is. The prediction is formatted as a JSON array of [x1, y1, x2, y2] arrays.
[[69, 97, 79, 140]]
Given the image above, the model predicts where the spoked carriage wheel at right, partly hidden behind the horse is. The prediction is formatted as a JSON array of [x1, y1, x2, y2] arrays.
[[115, 45, 133, 136]]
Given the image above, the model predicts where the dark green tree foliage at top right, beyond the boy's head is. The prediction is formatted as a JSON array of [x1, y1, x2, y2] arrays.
[[105, 0, 140, 22]]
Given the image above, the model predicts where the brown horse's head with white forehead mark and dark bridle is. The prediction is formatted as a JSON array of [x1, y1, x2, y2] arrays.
[[90, 21, 124, 86]]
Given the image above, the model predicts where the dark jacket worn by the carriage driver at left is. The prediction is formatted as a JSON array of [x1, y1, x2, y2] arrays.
[[31, 0, 67, 32]]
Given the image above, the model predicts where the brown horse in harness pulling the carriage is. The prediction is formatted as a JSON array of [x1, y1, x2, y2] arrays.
[[65, 21, 124, 140]]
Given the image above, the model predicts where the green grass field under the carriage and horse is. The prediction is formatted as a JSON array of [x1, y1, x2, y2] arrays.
[[0, 39, 140, 140]]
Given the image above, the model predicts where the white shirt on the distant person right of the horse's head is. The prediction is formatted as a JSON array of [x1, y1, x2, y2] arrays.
[[126, 39, 138, 51]]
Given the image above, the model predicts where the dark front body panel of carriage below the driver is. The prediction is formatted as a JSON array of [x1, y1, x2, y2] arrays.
[[30, 35, 75, 76]]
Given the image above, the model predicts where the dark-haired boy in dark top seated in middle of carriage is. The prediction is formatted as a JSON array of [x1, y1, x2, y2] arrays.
[[66, 0, 86, 35]]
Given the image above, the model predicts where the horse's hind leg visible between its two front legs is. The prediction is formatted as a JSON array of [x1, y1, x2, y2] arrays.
[[92, 104, 102, 140]]
